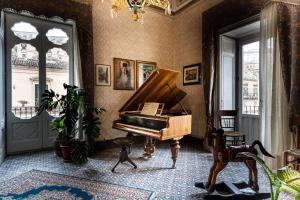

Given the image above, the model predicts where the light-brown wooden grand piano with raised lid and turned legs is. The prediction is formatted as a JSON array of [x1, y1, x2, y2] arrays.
[[113, 69, 192, 168]]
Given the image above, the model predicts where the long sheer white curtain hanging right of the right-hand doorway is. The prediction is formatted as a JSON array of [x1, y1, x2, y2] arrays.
[[260, 4, 290, 169]]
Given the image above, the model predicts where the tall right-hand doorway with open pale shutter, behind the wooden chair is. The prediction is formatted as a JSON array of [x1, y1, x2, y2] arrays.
[[218, 21, 260, 143]]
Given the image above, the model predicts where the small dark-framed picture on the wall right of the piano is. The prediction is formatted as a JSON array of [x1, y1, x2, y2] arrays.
[[183, 63, 202, 85]]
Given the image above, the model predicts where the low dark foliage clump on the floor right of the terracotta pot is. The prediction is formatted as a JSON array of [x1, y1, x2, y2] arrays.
[[71, 140, 88, 164]]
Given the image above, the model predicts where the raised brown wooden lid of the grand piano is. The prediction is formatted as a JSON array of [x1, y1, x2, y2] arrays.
[[119, 68, 186, 112]]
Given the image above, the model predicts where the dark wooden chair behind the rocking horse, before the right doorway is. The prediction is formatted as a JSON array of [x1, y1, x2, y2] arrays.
[[218, 110, 246, 146]]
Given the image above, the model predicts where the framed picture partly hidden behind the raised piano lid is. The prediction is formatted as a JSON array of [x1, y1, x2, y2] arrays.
[[136, 60, 156, 88]]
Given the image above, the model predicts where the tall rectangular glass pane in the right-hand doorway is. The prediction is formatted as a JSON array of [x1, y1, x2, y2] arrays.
[[242, 41, 260, 115]]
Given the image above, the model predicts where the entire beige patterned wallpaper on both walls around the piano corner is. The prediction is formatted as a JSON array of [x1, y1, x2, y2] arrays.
[[93, 0, 221, 140]]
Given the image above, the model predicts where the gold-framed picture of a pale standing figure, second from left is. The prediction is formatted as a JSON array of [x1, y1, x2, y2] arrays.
[[114, 58, 135, 90]]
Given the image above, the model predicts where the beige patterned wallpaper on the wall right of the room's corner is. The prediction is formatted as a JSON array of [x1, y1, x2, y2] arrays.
[[173, 0, 222, 138]]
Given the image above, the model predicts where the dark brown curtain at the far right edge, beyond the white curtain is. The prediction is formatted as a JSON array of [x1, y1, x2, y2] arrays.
[[273, 0, 300, 128]]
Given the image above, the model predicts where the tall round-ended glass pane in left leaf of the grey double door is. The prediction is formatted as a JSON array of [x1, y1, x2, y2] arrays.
[[11, 43, 39, 119]]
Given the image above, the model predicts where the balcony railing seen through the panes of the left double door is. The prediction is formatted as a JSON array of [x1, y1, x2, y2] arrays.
[[12, 106, 61, 119]]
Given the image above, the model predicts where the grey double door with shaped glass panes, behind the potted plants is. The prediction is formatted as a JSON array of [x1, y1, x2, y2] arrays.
[[2, 11, 74, 154]]
